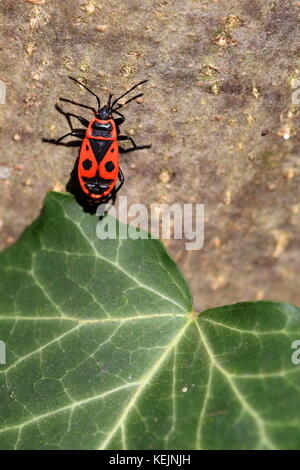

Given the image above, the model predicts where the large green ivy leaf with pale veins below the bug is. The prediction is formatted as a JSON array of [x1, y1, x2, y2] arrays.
[[0, 193, 300, 449]]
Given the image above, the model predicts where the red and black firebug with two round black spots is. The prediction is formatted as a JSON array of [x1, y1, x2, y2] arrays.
[[48, 77, 151, 203]]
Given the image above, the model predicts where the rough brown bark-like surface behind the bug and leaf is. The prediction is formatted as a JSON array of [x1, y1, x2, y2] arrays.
[[0, 0, 300, 308]]
